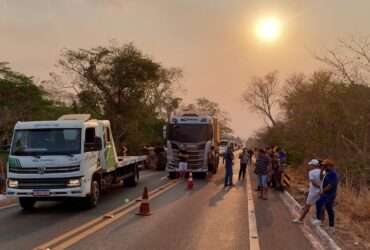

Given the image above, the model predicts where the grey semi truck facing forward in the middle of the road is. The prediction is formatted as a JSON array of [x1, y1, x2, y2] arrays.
[[165, 114, 220, 178]]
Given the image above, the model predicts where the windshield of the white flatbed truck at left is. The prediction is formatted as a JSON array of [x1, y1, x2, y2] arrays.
[[11, 128, 81, 156]]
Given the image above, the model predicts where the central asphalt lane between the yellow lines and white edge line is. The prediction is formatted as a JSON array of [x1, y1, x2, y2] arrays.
[[71, 168, 249, 250]]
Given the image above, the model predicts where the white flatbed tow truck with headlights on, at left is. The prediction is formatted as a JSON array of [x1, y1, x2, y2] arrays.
[[6, 114, 145, 210]]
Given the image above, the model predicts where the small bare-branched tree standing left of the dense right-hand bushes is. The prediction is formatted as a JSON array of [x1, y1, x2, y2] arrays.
[[243, 71, 279, 126]]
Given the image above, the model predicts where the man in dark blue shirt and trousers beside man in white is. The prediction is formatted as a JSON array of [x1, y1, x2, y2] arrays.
[[313, 159, 339, 233]]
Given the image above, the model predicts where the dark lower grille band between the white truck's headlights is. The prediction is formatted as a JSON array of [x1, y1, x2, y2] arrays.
[[16, 178, 73, 189]]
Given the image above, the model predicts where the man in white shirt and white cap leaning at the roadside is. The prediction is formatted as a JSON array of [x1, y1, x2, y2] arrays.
[[292, 159, 321, 224]]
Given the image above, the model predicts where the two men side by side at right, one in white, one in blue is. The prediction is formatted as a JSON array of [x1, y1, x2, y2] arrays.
[[293, 159, 339, 232]]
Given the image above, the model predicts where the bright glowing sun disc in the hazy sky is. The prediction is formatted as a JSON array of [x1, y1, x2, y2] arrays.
[[256, 17, 281, 42]]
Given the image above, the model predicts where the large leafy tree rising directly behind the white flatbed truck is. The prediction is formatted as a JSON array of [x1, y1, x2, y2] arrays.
[[59, 44, 181, 152]]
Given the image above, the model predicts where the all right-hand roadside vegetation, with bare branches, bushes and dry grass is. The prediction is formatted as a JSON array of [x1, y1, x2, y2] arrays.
[[243, 36, 370, 249]]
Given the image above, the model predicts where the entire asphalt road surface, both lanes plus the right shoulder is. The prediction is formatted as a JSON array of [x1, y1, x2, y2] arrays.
[[0, 161, 313, 250]]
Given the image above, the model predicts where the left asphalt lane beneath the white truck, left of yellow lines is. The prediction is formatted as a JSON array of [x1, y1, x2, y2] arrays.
[[0, 171, 166, 250]]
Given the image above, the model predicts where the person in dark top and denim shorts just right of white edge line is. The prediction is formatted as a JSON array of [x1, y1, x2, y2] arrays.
[[254, 149, 271, 200]]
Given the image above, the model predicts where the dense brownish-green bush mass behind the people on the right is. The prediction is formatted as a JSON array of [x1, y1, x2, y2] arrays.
[[254, 72, 370, 186]]
